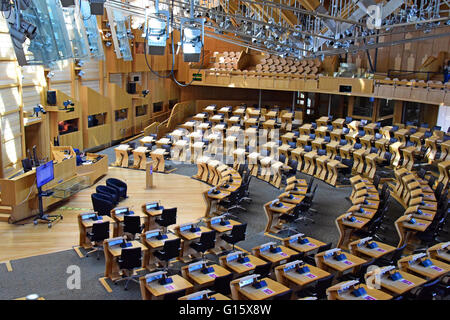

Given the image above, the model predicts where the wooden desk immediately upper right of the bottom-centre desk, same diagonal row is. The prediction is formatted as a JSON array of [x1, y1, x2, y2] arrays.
[[275, 263, 330, 290]]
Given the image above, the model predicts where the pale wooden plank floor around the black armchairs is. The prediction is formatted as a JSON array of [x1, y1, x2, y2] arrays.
[[0, 167, 210, 262]]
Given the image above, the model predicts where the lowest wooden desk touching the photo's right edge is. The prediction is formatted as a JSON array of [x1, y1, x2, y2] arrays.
[[398, 256, 450, 280]]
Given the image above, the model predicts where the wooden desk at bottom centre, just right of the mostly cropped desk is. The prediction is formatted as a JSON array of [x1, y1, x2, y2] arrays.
[[230, 278, 289, 300]]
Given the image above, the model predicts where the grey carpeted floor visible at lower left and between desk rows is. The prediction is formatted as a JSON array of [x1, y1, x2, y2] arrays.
[[0, 139, 436, 300]]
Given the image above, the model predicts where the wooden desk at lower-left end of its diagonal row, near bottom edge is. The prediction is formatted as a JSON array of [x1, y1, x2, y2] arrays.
[[139, 274, 194, 300]]
